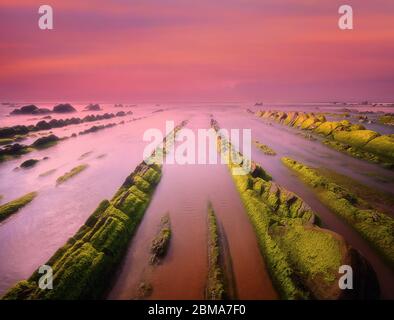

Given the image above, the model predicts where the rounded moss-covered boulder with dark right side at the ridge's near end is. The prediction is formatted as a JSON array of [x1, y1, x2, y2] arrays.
[[271, 225, 380, 300]]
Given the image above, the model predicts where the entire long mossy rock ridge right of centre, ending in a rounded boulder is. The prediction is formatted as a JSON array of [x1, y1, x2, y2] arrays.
[[216, 123, 379, 299]]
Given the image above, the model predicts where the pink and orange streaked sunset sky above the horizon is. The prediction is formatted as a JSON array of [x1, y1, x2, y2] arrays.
[[0, 0, 394, 102]]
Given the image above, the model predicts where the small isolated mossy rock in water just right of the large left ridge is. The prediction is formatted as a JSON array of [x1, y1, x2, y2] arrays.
[[150, 213, 171, 264]]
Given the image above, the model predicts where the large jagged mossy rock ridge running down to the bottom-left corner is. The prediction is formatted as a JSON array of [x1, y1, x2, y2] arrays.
[[3, 163, 161, 300]]
